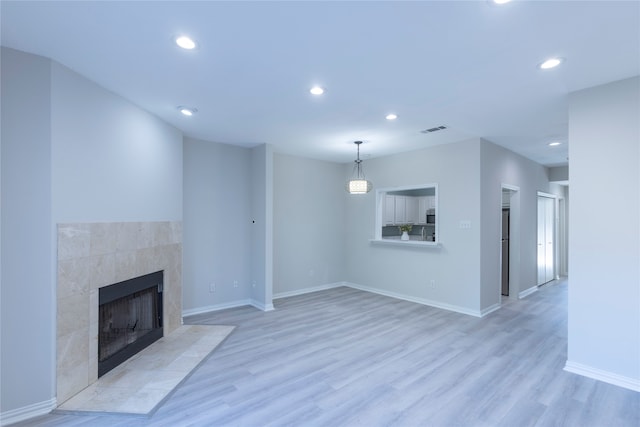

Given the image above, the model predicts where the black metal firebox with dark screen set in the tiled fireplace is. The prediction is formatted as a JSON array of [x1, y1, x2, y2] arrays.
[[98, 271, 163, 377]]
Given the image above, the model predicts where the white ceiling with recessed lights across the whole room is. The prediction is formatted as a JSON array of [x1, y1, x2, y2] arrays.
[[0, 0, 640, 166]]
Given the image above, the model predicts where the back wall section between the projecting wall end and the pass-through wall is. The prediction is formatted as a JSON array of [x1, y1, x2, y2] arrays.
[[273, 154, 348, 298]]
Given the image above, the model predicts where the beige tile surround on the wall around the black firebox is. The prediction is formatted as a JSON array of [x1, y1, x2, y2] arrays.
[[56, 222, 182, 405]]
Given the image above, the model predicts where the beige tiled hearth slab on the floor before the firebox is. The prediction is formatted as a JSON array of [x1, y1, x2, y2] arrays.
[[56, 325, 234, 415]]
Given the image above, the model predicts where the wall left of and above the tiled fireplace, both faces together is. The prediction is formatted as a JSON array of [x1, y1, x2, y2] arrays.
[[0, 48, 182, 413]]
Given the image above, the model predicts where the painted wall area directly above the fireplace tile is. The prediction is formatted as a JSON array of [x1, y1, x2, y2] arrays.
[[51, 62, 182, 223]]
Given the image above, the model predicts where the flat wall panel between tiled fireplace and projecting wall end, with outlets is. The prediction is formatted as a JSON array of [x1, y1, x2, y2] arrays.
[[183, 138, 252, 313]]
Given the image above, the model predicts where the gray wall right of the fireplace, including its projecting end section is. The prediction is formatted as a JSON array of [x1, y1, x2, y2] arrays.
[[183, 142, 273, 315]]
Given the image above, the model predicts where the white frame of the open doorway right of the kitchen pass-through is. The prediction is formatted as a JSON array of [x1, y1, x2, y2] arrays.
[[496, 183, 520, 305]]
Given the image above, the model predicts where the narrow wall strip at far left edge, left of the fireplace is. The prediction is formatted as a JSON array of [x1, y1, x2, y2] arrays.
[[0, 48, 55, 413]]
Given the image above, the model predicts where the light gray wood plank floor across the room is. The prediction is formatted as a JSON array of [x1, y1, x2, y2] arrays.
[[12, 281, 640, 427]]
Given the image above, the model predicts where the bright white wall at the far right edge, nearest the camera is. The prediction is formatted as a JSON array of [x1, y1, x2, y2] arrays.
[[567, 77, 640, 390]]
